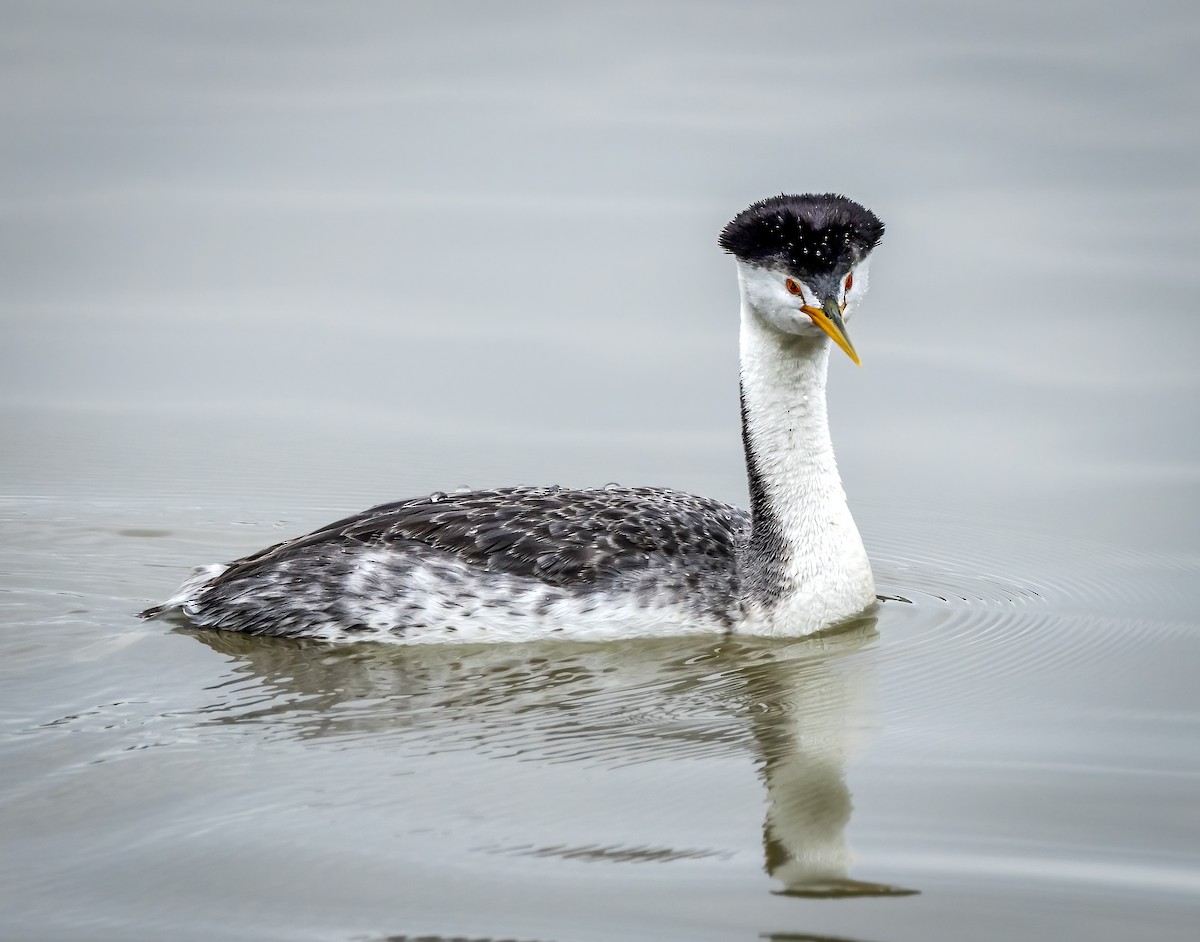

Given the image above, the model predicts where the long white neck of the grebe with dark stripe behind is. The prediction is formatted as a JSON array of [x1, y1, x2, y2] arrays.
[[739, 309, 875, 635]]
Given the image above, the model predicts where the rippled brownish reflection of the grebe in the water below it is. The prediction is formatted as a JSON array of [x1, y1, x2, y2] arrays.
[[188, 614, 908, 896]]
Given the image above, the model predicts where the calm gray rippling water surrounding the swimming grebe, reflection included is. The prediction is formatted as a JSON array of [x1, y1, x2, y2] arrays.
[[0, 0, 1200, 942]]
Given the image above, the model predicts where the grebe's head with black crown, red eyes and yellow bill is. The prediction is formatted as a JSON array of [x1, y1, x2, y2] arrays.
[[719, 193, 883, 364]]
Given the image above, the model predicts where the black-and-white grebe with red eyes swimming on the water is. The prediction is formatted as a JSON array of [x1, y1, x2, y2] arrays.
[[143, 196, 883, 642]]
